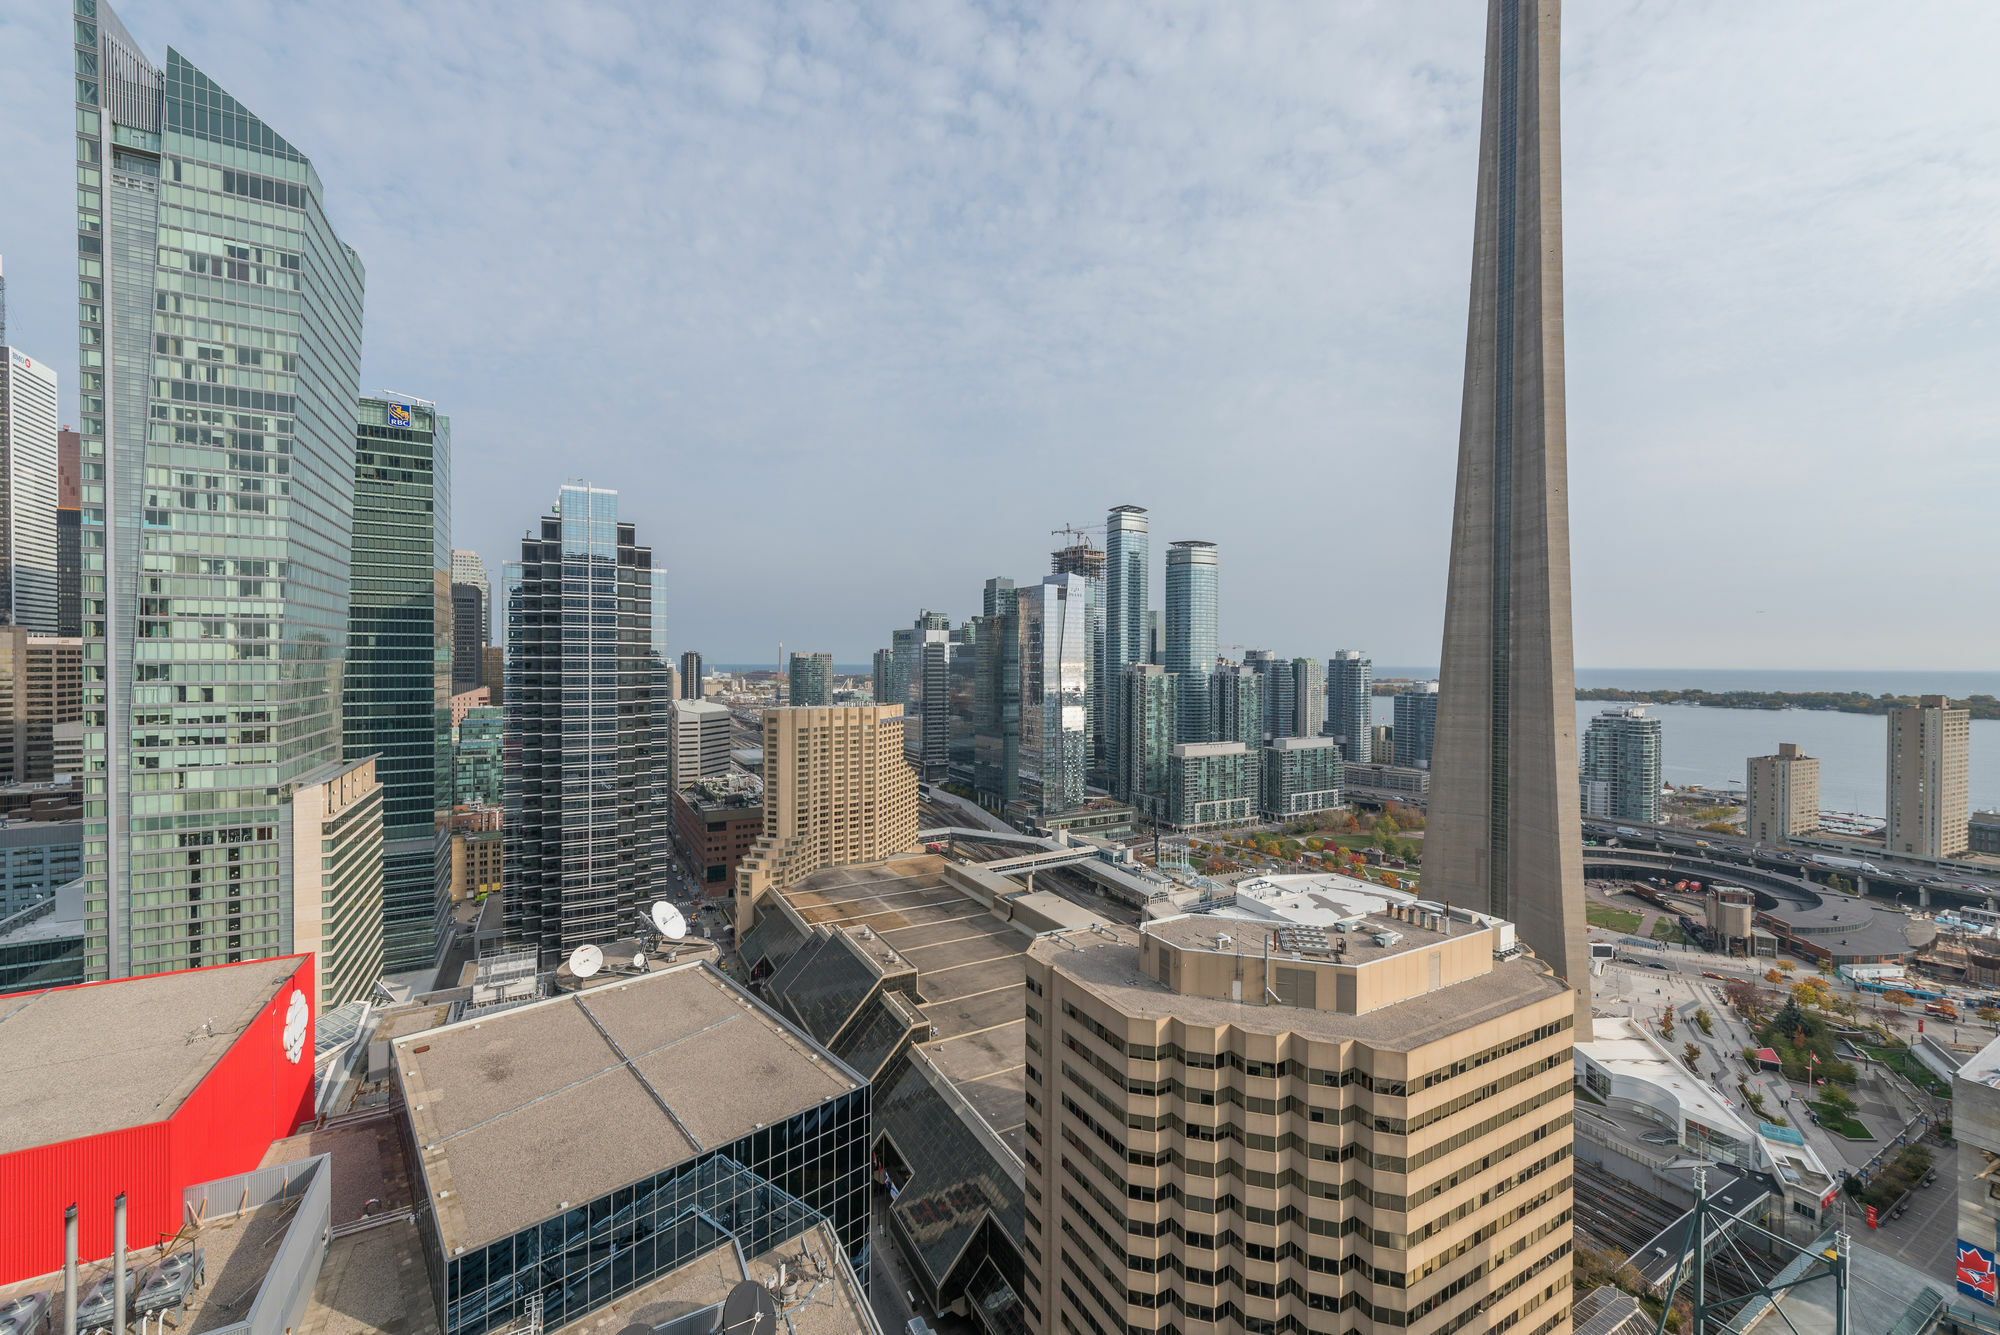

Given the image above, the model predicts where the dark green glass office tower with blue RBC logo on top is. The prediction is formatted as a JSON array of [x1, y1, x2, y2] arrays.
[[346, 398, 458, 971]]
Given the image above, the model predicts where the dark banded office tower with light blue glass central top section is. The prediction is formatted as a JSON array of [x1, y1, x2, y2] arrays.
[[504, 482, 668, 967]]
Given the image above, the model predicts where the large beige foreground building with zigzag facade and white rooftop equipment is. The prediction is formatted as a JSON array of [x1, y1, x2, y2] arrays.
[[1022, 877, 1576, 1335]]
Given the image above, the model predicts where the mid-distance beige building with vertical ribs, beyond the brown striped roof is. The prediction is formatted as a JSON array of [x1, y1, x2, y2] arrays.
[[736, 705, 916, 931]]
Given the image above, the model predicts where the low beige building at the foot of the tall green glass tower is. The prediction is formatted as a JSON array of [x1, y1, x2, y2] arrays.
[[284, 755, 382, 1015]]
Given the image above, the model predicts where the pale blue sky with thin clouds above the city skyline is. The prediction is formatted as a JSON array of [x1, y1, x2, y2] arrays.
[[0, 0, 2000, 668]]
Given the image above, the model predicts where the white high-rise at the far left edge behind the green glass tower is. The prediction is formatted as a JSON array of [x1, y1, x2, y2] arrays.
[[0, 344, 60, 636]]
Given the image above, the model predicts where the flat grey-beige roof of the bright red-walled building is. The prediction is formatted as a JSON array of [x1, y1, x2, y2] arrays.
[[0, 955, 300, 1153]]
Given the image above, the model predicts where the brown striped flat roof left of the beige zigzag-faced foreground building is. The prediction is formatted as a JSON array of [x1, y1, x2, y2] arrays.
[[778, 849, 1032, 1155]]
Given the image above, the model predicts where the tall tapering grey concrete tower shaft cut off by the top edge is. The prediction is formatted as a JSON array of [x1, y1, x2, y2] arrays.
[[1424, 0, 1590, 1041]]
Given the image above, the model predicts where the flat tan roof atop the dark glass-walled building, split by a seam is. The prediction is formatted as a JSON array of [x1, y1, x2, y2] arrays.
[[394, 963, 860, 1255]]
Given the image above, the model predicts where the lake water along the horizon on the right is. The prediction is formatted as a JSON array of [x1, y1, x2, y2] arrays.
[[1374, 668, 2000, 815]]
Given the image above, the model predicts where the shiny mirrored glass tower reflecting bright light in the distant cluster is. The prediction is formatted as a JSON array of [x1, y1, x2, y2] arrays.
[[1014, 576, 1092, 817]]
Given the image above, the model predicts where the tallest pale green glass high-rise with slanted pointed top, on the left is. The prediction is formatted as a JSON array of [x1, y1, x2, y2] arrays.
[[77, 0, 364, 979]]
